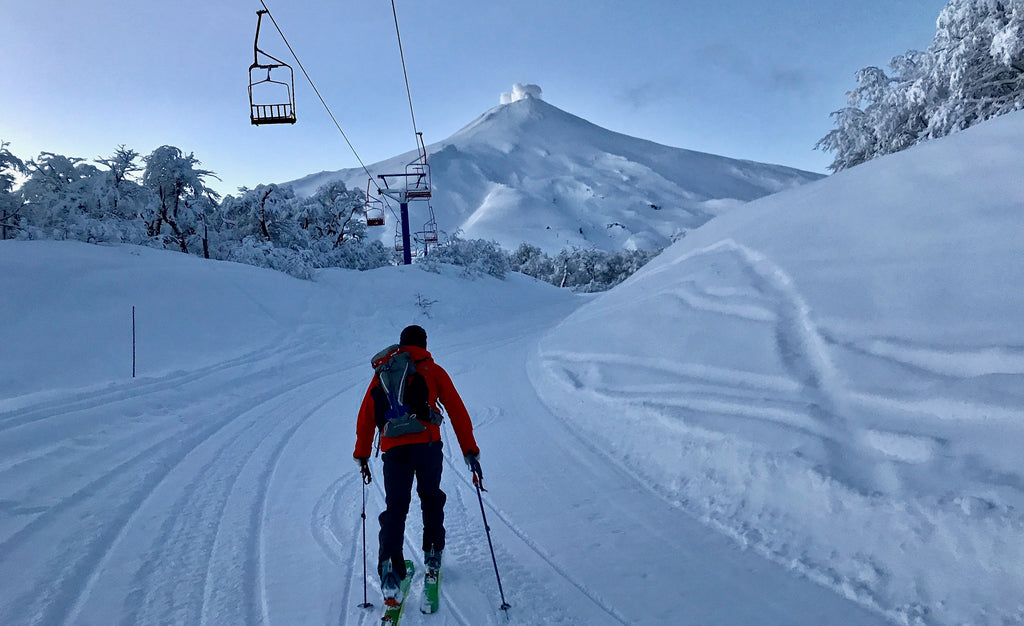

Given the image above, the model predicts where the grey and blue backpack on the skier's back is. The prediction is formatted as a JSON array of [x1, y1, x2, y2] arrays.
[[370, 344, 443, 436]]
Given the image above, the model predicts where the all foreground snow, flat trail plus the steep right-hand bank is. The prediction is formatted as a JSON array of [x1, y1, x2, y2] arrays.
[[0, 115, 1024, 625]]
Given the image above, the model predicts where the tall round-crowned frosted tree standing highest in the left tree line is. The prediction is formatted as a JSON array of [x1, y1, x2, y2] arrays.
[[142, 145, 219, 253]]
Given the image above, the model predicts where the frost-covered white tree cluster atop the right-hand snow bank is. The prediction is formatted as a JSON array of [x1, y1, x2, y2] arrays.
[[816, 0, 1024, 171]]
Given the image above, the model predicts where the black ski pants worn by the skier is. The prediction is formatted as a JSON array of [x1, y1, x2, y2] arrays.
[[377, 442, 447, 578]]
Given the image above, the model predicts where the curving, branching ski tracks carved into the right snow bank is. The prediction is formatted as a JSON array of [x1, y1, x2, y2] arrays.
[[544, 241, 927, 491]]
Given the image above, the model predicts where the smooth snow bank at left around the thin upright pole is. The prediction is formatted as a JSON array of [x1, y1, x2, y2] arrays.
[[0, 241, 308, 398]]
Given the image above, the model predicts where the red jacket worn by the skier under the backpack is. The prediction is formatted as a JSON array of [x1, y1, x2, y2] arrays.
[[352, 345, 480, 459]]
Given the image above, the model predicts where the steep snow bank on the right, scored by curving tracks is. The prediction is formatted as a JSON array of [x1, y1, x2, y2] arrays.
[[534, 114, 1024, 624]]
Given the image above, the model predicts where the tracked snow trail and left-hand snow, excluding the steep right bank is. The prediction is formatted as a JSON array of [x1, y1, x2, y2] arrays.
[[0, 241, 881, 626]]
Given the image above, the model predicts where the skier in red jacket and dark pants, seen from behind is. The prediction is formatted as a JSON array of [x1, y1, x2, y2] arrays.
[[352, 326, 482, 606]]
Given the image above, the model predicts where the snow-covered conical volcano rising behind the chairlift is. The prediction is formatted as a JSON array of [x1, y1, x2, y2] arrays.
[[288, 96, 821, 254]]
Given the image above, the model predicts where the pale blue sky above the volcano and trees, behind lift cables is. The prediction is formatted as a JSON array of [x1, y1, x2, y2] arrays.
[[0, 0, 946, 193]]
